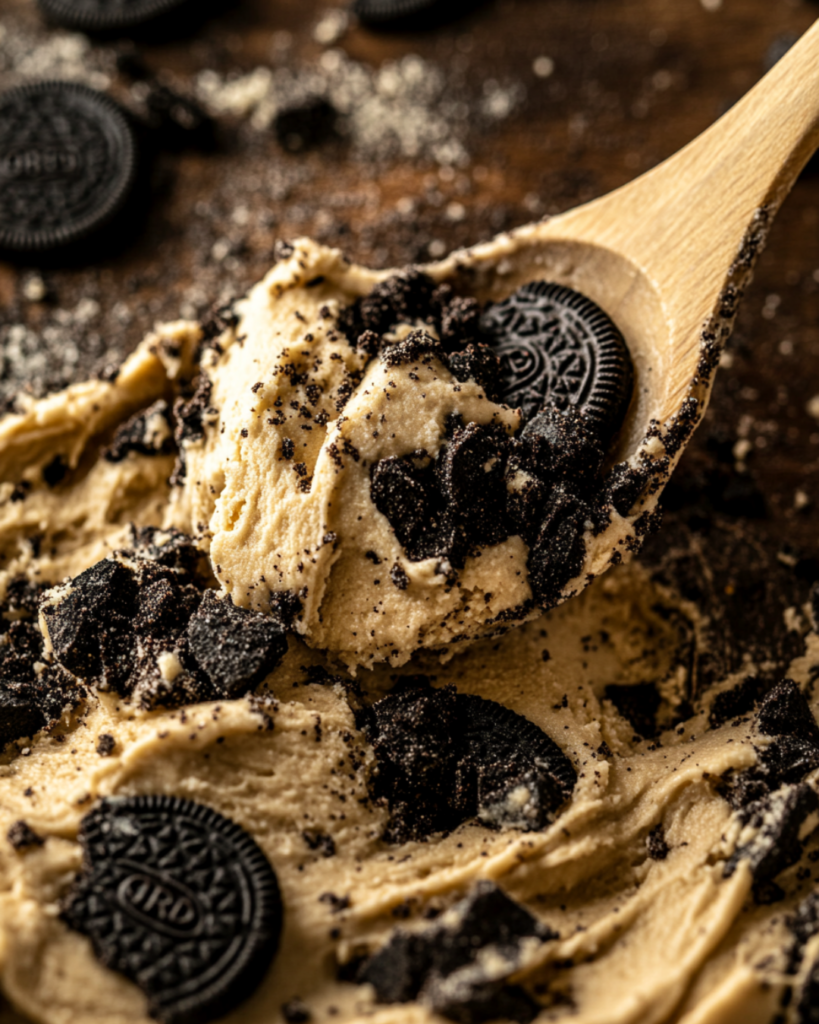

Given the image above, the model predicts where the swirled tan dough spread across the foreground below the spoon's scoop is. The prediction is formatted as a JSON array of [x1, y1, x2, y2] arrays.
[[0, 552, 819, 1024]]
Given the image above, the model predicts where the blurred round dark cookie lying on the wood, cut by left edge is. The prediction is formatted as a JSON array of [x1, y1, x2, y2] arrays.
[[0, 82, 137, 253]]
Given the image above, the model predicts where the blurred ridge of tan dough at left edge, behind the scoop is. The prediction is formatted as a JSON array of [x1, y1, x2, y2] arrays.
[[0, 322, 201, 591]]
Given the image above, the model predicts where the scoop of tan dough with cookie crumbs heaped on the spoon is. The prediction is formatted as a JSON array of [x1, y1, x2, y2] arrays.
[[176, 241, 646, 667]]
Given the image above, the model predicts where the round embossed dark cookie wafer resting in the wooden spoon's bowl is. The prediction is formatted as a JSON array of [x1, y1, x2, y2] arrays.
[[481, 281, 633, 436]]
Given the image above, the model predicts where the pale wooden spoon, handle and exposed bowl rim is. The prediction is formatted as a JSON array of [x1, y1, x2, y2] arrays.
[[426, 20, 819, 598]]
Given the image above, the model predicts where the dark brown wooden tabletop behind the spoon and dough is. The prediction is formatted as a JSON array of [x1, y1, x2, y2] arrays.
[[0, 0, 819, 598]]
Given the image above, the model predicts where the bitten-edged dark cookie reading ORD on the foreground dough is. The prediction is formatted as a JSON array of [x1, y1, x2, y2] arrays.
[[63, 796, 283, 1024]]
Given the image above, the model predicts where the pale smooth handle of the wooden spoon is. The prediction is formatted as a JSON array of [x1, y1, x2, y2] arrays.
[[548, 20, 819, 354]]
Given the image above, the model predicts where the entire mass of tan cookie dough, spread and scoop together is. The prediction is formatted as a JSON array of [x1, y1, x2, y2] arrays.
[[0, 235, 819, 1024]]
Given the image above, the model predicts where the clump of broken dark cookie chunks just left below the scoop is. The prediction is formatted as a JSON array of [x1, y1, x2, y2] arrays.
[[42, 530, 295, 708]]
